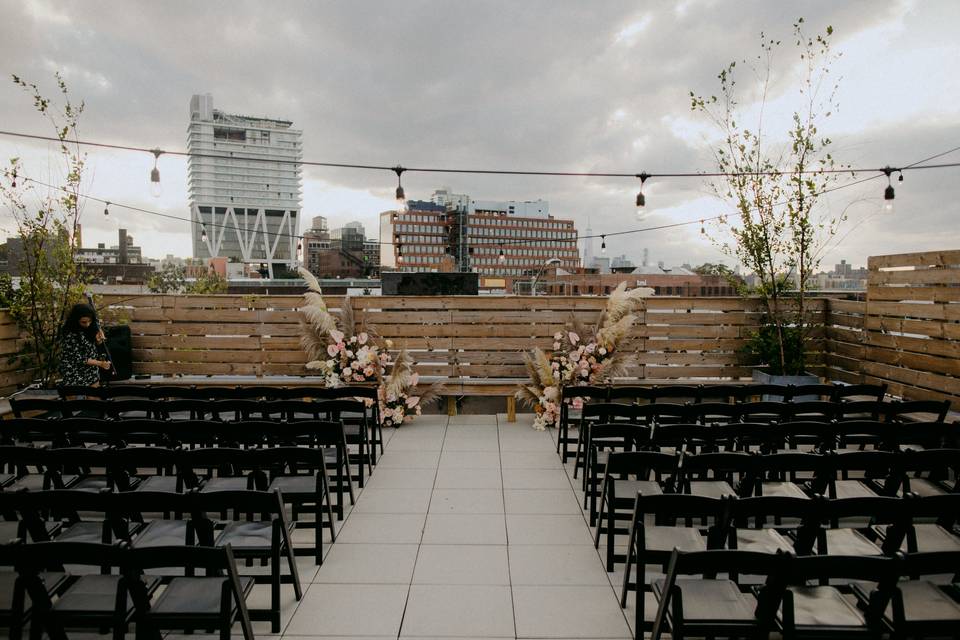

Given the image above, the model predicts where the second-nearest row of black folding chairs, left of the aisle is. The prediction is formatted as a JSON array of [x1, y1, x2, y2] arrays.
[[0, 490, 304, 633]]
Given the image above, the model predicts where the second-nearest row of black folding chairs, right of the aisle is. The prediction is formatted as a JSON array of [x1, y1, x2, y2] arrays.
[[606, 493, 960, 629]]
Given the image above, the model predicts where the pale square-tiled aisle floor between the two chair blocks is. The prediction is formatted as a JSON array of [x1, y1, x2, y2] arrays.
[[266, 414, 633, 638]]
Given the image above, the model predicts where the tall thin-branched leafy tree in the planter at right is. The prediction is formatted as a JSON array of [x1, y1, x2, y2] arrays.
[[690, 19, 849, 375]]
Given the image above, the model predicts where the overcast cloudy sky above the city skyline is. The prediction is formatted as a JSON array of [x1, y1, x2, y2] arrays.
[[0, 0, 960, 266]]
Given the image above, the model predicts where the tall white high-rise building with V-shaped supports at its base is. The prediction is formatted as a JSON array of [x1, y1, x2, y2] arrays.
[[187, 93, 302, 277]]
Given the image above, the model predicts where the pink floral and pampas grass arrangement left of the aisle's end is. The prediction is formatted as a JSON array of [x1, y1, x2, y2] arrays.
[[300, 267, 439, 427]]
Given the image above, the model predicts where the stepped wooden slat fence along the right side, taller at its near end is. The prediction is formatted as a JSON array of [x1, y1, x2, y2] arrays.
[[826, 251, 960, 410]]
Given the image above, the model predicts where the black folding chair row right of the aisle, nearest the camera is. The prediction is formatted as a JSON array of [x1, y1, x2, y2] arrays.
[[636, 550, 960, 639]]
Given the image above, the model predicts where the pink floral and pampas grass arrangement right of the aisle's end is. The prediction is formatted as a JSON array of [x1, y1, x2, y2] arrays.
[[516, 282, 652, 430]]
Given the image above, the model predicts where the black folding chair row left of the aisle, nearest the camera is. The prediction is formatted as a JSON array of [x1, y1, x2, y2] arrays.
[[0, 542, 254, 640]]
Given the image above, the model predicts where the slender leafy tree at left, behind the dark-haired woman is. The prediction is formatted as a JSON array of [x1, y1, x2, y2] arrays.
[[0, 74, 89, 386]]
